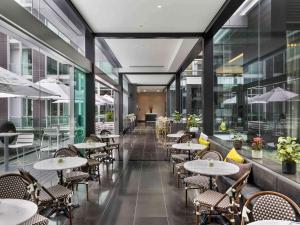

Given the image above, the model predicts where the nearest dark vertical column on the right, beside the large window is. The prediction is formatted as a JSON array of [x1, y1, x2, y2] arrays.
[[202, 37, 214, 135]]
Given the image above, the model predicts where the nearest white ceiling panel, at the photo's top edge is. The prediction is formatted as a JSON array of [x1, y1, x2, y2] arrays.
[[72, 0, 226, 33]]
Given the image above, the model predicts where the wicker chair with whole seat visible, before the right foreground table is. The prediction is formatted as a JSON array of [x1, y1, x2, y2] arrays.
[[194, 170, 250, 225]]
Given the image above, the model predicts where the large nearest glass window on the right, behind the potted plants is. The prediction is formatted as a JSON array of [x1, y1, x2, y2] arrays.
[[214, 0, 300, 173]]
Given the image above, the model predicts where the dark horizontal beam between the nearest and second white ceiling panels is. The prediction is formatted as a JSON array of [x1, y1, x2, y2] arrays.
[[94, 32, 204, 39]]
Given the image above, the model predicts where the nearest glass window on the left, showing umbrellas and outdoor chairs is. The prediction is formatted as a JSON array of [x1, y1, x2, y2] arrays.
[[0, 19, 85, 161]]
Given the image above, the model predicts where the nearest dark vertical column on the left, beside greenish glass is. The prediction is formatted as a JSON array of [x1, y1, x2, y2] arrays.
[[85, 31, 95, 137]]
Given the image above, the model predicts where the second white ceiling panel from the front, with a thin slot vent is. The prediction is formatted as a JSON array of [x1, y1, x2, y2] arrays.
[[105, 39, 198, 72]]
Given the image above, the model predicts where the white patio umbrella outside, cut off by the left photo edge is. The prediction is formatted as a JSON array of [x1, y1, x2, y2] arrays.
[[0, 67, 56, 98]]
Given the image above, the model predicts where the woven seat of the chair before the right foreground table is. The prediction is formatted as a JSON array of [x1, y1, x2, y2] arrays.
[[194, 190, 230, 209]]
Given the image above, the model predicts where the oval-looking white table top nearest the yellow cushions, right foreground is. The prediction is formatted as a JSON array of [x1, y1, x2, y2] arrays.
[[184, 159, 240, 176]]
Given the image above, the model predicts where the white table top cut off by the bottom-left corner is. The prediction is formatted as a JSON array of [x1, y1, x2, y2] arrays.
[[0, 199, 38, 225]]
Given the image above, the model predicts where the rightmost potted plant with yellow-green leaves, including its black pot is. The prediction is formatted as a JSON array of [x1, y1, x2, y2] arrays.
[[277, 137, 300, 174]]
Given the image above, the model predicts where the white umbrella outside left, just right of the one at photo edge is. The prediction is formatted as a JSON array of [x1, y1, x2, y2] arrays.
[[35, 78, 70, 102]]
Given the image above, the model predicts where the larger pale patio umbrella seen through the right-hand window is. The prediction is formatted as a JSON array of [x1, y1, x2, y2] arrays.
[[251, 87, 298, 102]]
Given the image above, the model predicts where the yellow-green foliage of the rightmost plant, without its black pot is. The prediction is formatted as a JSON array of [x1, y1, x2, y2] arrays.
[[277, 137, 300, 162]]
